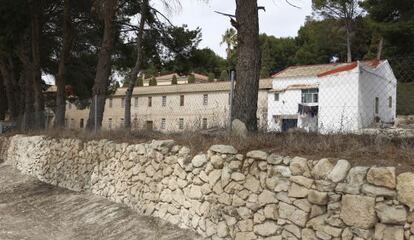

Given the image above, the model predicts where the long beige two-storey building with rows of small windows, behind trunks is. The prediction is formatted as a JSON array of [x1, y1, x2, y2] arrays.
[[65, 79, 272, 132]]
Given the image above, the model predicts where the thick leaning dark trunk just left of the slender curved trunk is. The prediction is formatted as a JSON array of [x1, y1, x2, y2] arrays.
[[86, 0, 118, 130]]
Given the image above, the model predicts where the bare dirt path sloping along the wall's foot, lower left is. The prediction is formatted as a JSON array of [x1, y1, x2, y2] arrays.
[[0, 163, 199, 240]]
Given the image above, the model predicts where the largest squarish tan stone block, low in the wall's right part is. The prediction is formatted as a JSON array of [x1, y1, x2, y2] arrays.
[[340, 194, 377, 229]]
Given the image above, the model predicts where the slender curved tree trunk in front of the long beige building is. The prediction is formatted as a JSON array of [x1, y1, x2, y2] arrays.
[[124, 0, 148, 129]]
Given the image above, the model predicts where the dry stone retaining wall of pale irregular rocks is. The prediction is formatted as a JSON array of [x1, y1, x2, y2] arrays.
[[2, 136, 414, 240]]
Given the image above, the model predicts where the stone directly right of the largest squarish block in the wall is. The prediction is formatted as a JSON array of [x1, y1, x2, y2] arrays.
[[375, 203, 407, 224]]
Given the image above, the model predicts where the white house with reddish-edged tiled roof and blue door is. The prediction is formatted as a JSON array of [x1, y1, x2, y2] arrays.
[[267, 61, 397, 133]]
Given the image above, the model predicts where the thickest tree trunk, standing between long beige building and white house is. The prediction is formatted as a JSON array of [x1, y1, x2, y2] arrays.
[[232, 0, 260, 131]]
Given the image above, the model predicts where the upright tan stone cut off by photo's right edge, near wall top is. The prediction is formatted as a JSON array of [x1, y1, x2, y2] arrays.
[[397, 172, 414, 211]]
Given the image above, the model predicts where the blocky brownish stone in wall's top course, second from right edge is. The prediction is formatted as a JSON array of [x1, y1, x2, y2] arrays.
[[367, 167, 395, 189]]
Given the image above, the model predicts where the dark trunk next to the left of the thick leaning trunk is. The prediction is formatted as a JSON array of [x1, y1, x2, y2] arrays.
[[54, 0, 73, 128]]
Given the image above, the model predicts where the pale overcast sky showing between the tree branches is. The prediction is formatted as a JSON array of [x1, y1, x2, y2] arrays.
[[160, 0, 312, 57]]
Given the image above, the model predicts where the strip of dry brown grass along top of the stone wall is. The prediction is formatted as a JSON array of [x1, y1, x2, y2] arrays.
[[8, 130, 414, 172]]
